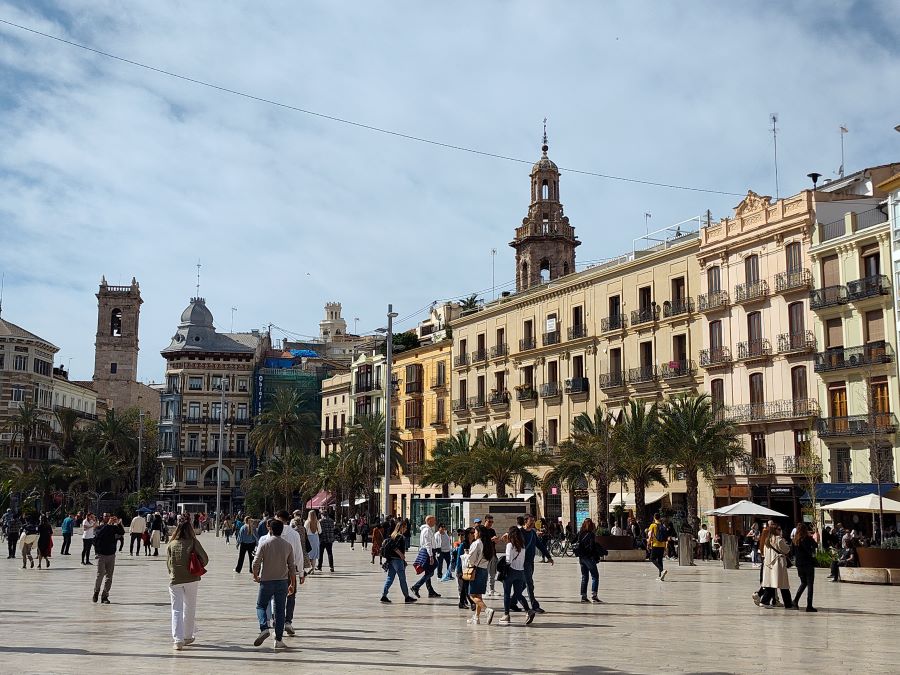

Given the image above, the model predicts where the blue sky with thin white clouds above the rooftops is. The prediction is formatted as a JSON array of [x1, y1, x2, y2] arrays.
[[0, 0, 900, 381]]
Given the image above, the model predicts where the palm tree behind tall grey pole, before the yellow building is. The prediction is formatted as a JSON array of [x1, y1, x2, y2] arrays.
[[341, 413, 406, 519]]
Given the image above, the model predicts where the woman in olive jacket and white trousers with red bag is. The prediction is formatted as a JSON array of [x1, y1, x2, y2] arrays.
[[166, 515, 209, 651]]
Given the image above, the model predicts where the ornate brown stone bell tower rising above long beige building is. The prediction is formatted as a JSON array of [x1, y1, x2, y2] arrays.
[[509, 125, 581, 292]]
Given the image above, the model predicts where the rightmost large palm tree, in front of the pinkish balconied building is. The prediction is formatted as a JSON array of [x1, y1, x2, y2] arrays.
[[658, 394, 746, 528]]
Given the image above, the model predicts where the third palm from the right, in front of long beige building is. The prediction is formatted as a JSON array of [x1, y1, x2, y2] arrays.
[[544, 406, 618, 522]]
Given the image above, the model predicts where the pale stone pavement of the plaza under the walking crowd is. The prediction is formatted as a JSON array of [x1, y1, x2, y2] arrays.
[[0, 533, 900, 675]]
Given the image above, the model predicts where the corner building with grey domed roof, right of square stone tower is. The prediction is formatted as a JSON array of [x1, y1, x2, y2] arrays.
[[157, 298, 264, 512]]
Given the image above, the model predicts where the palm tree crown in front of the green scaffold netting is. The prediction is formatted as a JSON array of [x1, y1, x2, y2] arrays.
[[250, 387, 319, 459]]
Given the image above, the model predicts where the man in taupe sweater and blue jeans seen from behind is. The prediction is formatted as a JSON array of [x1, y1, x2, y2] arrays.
[[253, 518, 297, 649]]
